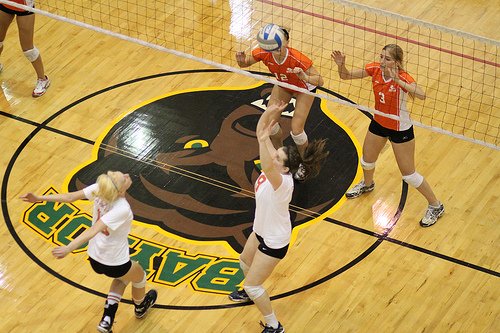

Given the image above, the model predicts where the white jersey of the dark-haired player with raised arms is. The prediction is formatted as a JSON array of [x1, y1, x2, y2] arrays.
[[253, 172, 293, 249]]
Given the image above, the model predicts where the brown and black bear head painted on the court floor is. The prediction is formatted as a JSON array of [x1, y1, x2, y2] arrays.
[[69, 84, 358, 252]]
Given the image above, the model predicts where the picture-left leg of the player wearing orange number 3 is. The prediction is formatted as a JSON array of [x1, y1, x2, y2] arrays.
[[346, 130, 387, 199]]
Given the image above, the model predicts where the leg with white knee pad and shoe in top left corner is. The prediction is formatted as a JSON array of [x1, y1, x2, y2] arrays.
[[16, 14, 50, 97]]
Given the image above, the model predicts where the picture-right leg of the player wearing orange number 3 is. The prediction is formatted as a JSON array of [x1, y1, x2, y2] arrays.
[[391, 139, 444, 227]]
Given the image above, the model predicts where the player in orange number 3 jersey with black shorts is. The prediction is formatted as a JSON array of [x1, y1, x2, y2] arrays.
[[332, 44, 444, 227]]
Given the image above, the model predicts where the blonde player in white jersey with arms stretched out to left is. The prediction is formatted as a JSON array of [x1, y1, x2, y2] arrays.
[[21, 171, 157, 333]]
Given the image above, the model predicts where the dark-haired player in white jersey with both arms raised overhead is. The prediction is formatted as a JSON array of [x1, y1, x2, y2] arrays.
[[229, 101, 328, 333]]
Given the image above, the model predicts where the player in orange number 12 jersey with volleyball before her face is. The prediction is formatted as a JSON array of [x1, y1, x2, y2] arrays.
[[236, 24, 323, 180]]
